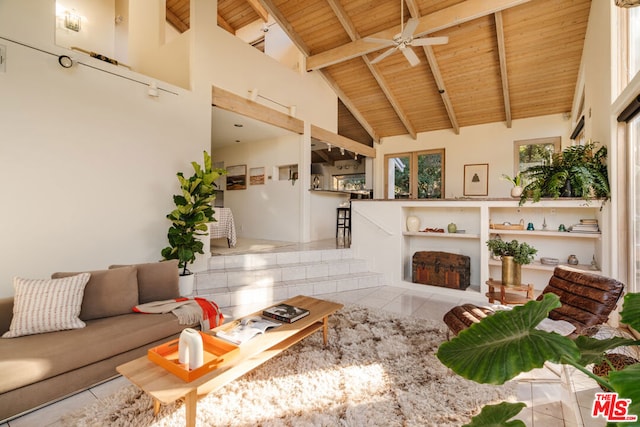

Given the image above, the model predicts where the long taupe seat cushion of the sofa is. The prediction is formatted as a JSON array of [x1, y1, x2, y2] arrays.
[[0, 313, 198, 394]]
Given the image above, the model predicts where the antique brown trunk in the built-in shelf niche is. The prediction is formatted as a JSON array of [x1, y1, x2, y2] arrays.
[[412, 251, 471, 289]]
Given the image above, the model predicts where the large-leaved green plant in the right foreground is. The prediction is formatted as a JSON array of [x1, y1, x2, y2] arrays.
[[437, 293, 640, 427]]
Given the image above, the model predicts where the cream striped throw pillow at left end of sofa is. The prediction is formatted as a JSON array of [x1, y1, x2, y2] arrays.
[[0, 273, 90, 340]]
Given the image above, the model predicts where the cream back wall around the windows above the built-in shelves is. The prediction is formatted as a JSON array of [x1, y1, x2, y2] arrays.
[[374, 114, 571, 199]]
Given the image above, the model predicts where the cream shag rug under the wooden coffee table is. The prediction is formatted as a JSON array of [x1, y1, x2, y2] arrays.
[[63, 305, 516, 427]]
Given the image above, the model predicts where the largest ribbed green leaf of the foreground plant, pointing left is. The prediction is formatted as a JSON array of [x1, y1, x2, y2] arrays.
[[437, 293, 580, 384]]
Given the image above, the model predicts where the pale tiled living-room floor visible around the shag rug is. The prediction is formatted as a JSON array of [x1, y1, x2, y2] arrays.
[[0, 239, 606, 427]]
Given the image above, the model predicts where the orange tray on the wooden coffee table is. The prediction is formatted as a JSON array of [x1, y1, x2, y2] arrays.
[[147, 331, 240, 382]]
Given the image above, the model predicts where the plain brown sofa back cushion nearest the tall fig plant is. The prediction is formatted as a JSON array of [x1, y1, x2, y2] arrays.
[[109, 259, 180, 304]]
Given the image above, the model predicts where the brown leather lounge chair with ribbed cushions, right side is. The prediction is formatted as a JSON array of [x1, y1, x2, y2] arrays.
[[538, 266, 624, 333]]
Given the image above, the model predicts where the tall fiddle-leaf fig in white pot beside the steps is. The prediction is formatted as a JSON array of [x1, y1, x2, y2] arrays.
[[161, 151, 227, 295]]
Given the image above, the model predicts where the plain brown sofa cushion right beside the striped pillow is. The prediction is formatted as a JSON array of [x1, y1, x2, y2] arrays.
[[51, 267, 138, 320]]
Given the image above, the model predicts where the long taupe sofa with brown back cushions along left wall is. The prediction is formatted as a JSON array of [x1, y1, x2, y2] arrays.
[[0, 261, 199, 422]]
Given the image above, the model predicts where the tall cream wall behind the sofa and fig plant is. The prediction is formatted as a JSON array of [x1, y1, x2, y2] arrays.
[[0, 0, 337, 297]]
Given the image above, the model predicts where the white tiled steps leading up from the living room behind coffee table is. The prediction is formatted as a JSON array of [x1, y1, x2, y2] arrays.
[[194, 248, 384, 307]]
